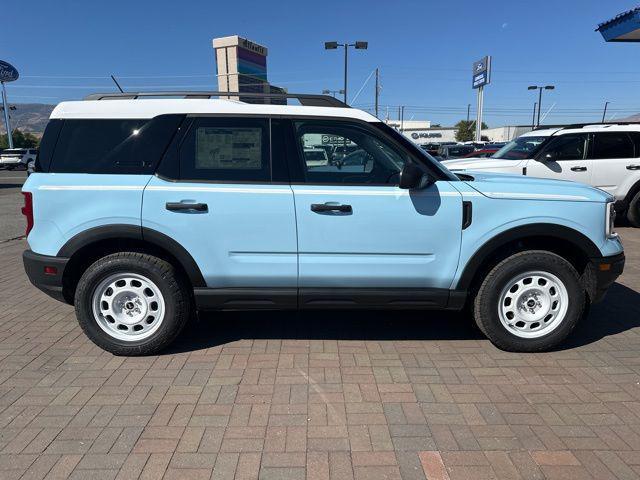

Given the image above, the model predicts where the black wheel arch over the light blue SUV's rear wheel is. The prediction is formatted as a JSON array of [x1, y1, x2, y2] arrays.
[[57, 225, 206, 303]]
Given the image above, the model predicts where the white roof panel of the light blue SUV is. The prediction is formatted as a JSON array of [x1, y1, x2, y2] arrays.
[[51, 98, 380, 122]]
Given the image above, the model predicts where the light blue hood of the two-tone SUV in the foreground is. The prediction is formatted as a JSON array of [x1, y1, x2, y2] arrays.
[[461, 171, 613, 202]]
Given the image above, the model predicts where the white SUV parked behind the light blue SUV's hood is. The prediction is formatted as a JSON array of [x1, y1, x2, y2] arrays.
[[442, 123, 640, 227]]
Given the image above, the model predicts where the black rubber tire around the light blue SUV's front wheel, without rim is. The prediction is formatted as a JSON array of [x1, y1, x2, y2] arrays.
[[473, 250, 587, 352]]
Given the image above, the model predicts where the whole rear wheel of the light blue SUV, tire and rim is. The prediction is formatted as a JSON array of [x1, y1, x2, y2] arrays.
[[75, 252, 191, 355]]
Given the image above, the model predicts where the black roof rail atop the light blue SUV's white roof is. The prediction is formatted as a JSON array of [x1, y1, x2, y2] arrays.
[[84, 91, 349, 108]]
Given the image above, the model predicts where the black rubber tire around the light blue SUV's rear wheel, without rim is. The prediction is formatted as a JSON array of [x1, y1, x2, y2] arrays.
[[75, 252, 191, 356]]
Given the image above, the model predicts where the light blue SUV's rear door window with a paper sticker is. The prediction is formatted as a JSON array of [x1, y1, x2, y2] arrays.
[[180, 118, 271, 182]]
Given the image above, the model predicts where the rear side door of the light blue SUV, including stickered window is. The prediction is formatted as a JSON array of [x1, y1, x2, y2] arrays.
[[142, 117, 298, 294]]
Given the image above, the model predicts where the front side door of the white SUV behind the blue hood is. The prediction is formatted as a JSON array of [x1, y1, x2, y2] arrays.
[[526, 133, 593, 184]]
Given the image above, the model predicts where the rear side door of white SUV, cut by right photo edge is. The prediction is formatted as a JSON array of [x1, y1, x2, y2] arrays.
[[591, 132, 640, 200]]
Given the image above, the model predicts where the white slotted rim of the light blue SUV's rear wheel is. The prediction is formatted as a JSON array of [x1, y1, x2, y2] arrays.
[[92, 273, 165, 342]]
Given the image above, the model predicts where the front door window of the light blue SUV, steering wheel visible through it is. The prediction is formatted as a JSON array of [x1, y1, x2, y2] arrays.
[[295, 122, 408, 184]]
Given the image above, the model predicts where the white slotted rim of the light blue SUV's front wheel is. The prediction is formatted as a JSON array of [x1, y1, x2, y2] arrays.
[[498, 271, 569, 338]]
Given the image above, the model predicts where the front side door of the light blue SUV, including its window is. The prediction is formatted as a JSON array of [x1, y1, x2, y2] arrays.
[[291, 120, 462, 306]]
